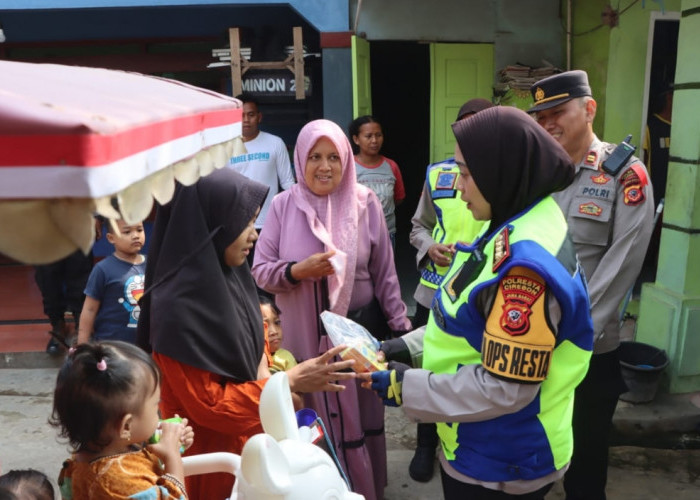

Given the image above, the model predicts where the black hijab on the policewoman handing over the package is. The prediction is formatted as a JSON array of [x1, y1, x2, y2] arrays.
[[452, 106, 575, 229]]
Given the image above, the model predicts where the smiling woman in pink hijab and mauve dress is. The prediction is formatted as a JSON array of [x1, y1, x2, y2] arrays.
[[253, 120, 410, 500]]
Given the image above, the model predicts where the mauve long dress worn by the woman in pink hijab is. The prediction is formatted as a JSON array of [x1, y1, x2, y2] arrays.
[[253, 186, 410, 500]]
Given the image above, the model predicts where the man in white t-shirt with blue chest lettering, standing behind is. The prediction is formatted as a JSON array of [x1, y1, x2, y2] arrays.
[[229, 94, 294, 266]]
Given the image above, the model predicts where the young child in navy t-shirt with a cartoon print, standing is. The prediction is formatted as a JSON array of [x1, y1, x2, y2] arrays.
[[78, 220, 146, 344]]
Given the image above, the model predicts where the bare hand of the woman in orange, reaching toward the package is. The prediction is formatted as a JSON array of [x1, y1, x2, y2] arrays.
[[287, 345, 355, 392]]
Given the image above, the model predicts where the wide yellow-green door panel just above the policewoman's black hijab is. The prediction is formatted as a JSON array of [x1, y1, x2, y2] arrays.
[[430, 43, 493, 163]]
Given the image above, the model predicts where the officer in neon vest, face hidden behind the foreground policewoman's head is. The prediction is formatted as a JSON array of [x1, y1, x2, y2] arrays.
[[408, 98, 493, 482]]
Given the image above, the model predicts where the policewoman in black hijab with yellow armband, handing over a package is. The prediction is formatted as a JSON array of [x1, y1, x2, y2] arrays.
[[365, 107, 593, 500]]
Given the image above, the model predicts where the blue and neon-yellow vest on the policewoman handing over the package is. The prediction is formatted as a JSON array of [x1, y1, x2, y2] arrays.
[[422, 197, 593, 482]]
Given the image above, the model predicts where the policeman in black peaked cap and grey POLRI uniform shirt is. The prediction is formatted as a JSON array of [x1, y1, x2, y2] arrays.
[[528, 71, 654, 500]]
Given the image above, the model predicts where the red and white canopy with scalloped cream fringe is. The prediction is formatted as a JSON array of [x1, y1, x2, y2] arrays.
[[0, 61, 242, 263]]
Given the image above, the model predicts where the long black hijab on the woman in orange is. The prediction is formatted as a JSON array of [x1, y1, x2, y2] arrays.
[[137, 168, 268, 382]]
